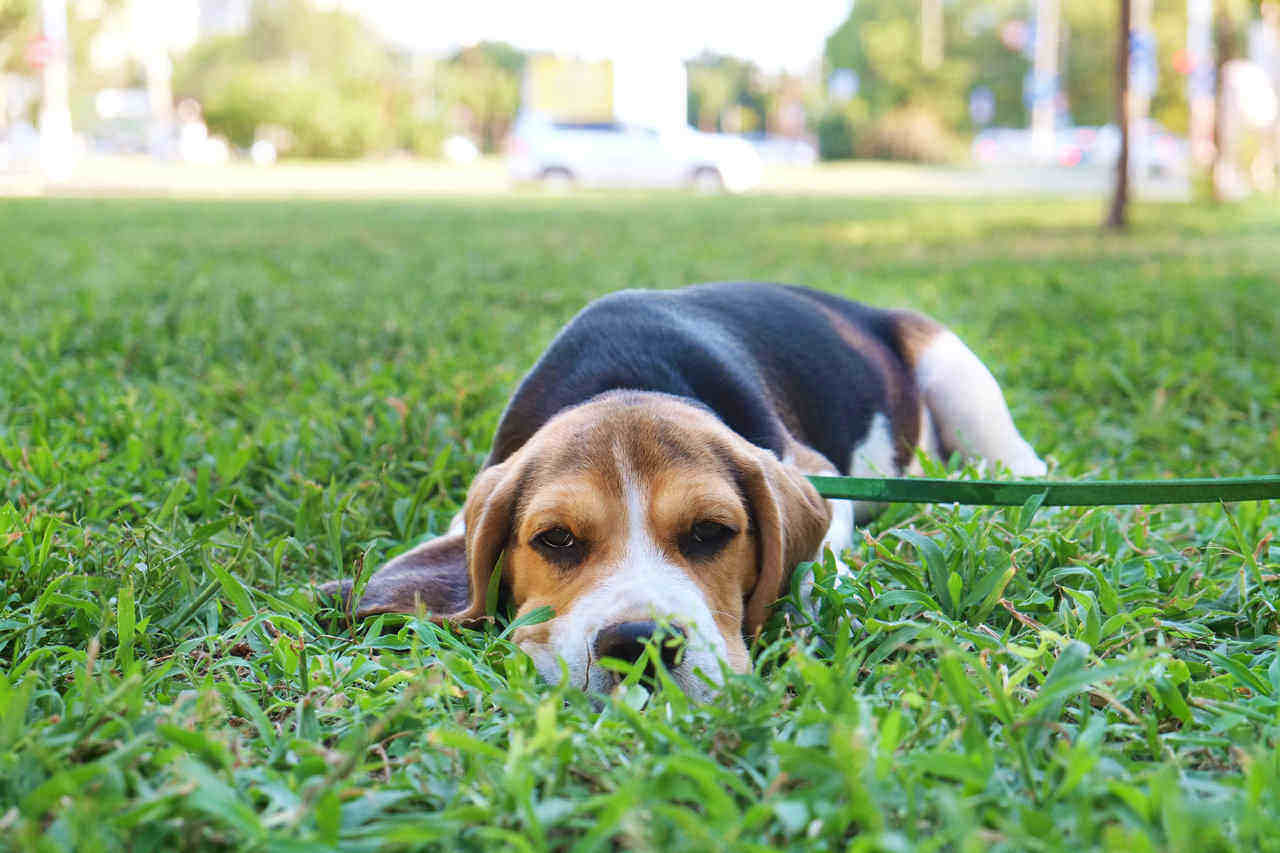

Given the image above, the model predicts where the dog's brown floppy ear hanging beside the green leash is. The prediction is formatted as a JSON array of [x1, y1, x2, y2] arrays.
[[739, 446, 831, 637]]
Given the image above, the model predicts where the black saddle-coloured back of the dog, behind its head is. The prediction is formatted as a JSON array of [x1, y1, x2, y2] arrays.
[[488, 282, 919, 473]]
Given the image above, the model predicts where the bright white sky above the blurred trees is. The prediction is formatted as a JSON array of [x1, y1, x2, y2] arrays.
[[329, 0, 851, 72]]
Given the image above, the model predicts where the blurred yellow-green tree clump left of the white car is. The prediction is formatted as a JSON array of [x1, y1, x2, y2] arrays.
[[174, 0, 525, 158]]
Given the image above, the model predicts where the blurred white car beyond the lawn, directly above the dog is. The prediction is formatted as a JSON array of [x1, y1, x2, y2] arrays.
[[507, 115, 760, 192]]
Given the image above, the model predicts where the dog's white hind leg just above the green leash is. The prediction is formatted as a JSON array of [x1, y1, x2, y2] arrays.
[[914, 327, 1048, 476]]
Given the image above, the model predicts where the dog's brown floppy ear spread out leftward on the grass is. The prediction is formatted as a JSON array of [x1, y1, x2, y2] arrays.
[[320, 460, 517, 624]]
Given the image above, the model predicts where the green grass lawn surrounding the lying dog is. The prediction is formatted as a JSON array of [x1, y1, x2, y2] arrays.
[[0, 196, 1280, 852]]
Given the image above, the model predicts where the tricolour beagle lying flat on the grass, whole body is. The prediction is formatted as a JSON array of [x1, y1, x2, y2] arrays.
[[323, 282, 1046, 698]]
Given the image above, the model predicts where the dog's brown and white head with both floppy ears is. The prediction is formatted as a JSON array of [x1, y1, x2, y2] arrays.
[[337, 392, 829, 695]]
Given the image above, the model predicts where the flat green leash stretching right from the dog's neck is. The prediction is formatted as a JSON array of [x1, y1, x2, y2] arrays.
[[809, 474, 1280, 506]]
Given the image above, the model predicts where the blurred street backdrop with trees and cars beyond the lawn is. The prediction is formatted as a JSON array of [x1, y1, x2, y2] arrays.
[[0, 0, 1280, 199]]
